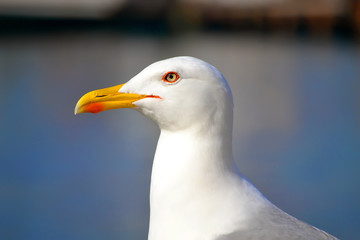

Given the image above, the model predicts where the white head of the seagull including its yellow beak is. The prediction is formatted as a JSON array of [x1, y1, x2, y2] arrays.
[[75, 57, 233, 131]]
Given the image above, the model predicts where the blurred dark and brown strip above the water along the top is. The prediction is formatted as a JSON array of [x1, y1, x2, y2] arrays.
[[0, 0, 360, 39]]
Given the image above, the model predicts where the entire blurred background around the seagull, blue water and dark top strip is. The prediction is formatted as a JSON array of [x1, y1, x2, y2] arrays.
[[0, 0, 360, 240]]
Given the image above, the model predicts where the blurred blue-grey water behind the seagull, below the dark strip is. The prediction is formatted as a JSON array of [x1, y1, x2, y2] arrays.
[[0, 33, 360, 240]]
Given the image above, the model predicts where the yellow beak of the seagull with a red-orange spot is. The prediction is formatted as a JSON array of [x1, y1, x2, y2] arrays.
[[74, 84, 147, 115]]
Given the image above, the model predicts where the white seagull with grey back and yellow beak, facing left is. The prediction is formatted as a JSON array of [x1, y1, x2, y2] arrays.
[[75, 56, 337, 240]]
